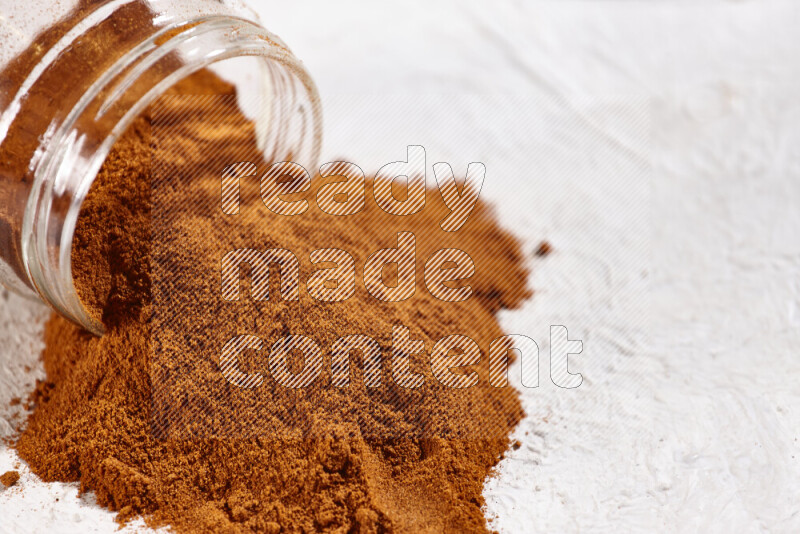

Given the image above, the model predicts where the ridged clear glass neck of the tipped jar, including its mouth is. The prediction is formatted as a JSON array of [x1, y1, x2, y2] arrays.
[[20, 15, 321, 335]]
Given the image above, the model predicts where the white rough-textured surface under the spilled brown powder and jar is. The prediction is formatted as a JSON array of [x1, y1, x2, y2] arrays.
[[0, 0, 800, 532]]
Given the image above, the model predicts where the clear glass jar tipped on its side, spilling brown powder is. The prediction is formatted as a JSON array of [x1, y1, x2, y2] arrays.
[[0, 0, 321, 334]]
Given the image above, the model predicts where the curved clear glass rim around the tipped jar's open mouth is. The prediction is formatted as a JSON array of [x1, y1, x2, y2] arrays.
[[21, 15, 322, 335]]
